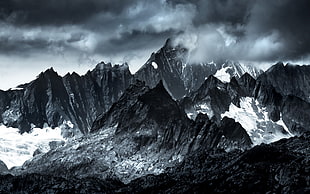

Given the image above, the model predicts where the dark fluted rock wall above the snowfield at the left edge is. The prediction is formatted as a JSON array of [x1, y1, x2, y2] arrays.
[[0, 63, 132, 133]]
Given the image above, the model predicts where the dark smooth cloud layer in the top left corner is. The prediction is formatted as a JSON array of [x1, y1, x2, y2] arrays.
[[0, 0, 134, 25]]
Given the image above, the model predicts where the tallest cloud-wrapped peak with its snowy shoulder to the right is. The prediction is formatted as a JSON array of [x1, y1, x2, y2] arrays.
[[135, 39, 262, 99]]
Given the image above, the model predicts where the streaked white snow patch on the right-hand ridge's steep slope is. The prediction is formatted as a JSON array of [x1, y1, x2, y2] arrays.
[[221, 97, 293, 145]]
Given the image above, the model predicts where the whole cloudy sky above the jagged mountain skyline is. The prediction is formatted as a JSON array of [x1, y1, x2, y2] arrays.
[[0, 0, 310, 89]]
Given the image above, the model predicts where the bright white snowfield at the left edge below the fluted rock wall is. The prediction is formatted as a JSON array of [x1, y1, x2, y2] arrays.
[[0, 124, 64, 169]]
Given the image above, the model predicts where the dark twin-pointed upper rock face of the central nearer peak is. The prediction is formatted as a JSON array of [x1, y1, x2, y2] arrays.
[[92, 81, 190, 149]]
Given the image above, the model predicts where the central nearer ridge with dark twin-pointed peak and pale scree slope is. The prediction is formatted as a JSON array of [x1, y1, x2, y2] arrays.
[[14, 81, 252, 183]]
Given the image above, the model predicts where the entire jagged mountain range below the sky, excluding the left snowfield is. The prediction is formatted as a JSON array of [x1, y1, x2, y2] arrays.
[[0, 39, 310, 193]]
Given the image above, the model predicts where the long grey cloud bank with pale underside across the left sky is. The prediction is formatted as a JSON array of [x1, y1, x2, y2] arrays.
[[0, 0, 195, 55]]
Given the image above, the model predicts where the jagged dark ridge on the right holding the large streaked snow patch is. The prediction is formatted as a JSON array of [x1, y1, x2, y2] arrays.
[[180, 73, 296, 144]]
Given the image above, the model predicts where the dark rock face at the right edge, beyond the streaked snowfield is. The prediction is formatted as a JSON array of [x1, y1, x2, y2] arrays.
[[253, 63, 310, 133]]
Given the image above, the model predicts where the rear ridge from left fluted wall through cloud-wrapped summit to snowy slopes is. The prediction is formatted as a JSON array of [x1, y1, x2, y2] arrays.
[[0, 39, 260, 137]]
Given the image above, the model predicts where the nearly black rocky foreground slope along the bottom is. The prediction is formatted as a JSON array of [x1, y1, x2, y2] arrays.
[[0, 133, 310, 193]]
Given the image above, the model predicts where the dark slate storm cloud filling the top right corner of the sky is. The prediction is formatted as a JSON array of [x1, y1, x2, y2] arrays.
[[247, 0, 310, 59]]
